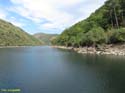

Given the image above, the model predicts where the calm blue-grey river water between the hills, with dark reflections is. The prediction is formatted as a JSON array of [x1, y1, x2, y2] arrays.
[[0, 47, 125, 93]]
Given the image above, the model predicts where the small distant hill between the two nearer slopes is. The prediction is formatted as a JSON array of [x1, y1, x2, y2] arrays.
[[33, 33, 58, 45]]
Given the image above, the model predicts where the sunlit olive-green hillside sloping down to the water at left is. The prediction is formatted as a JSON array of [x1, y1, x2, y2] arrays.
[[0, 19, 41, 46]]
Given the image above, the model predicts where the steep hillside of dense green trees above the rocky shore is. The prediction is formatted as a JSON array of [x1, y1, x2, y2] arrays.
[[52, 0, 125, 47]]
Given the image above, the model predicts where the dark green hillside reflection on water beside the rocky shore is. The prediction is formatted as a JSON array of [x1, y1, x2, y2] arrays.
[[57, 49, 125, 93]]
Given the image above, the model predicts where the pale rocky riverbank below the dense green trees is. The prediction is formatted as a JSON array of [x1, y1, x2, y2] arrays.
[[52, 44, 125, 56]]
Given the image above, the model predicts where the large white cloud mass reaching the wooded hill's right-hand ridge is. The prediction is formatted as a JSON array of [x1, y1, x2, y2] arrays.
[[11, 0, 106, 32]]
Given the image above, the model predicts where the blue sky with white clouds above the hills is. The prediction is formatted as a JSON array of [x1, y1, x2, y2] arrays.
[[0, 0, 106, 34]]
